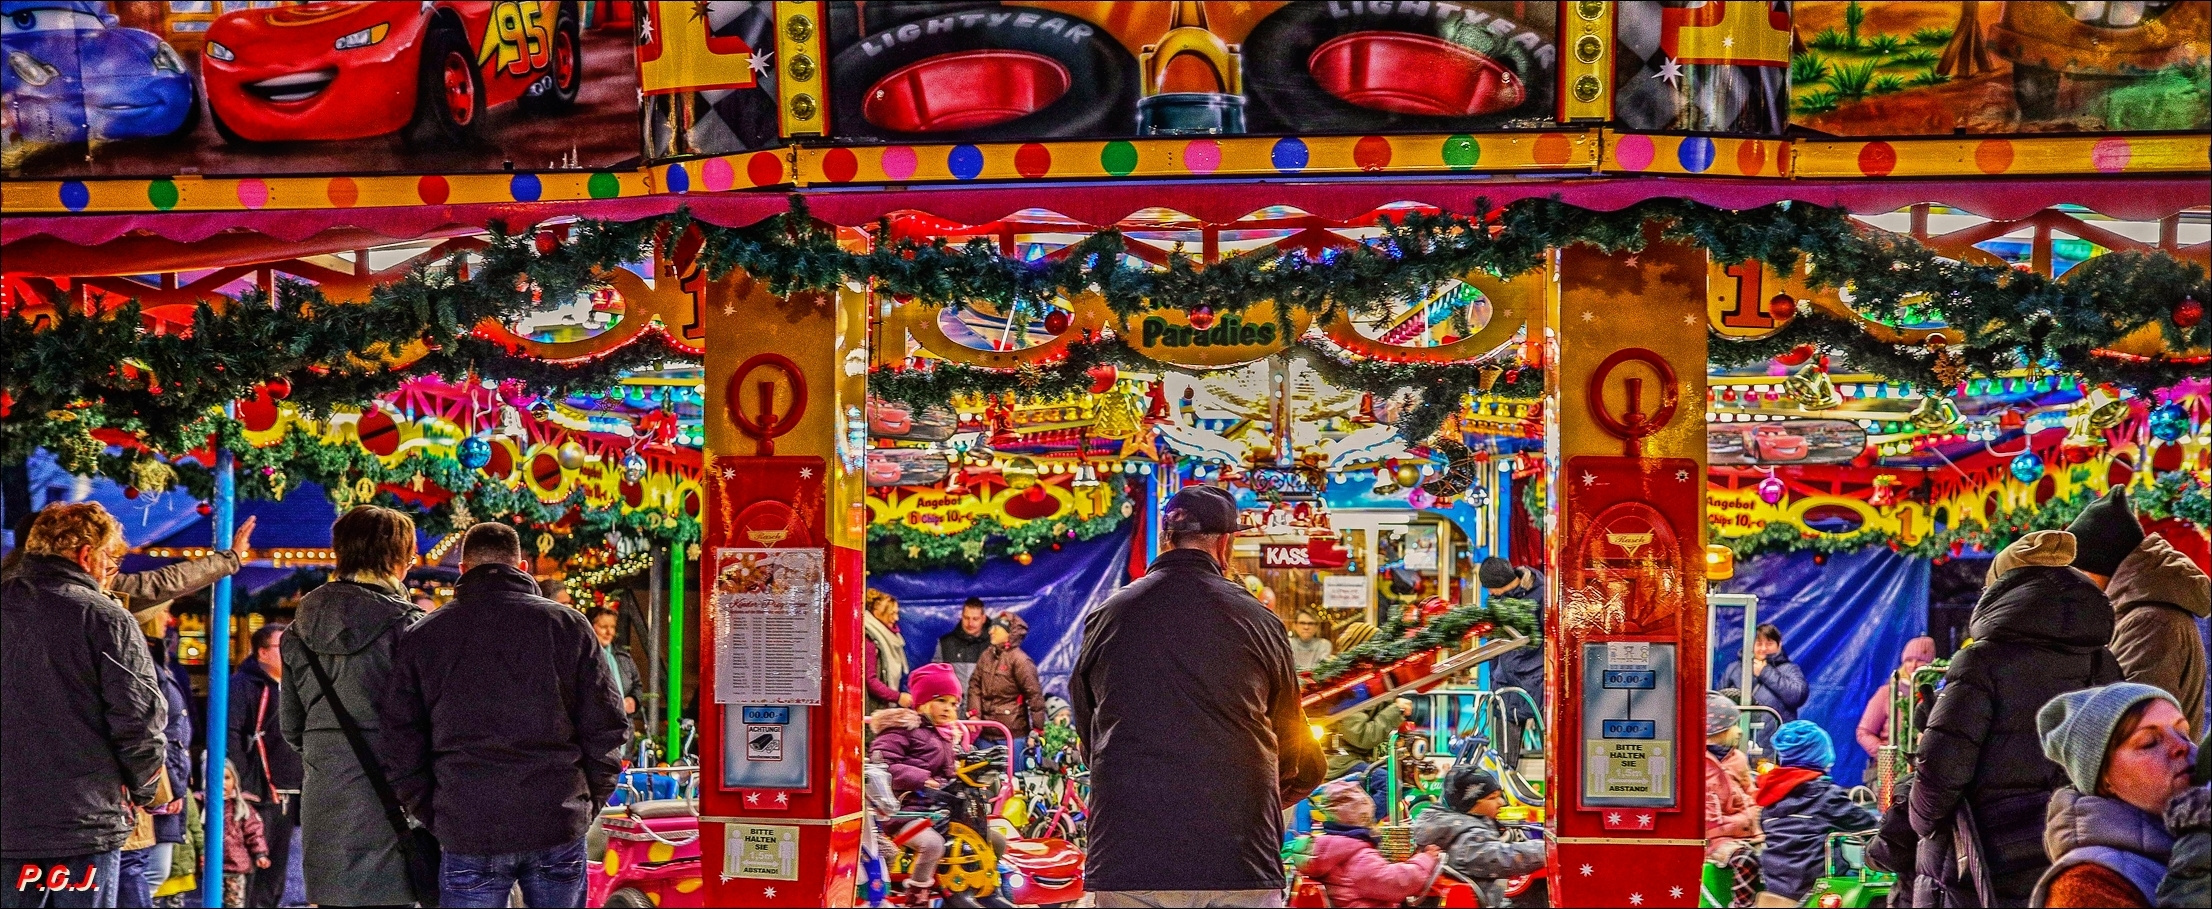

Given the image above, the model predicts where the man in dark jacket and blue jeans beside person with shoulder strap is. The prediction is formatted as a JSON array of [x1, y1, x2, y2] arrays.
[[380, 524, 630, 907]]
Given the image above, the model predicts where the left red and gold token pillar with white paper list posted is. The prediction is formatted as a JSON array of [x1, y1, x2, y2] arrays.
[[697, 274, 867, 907]]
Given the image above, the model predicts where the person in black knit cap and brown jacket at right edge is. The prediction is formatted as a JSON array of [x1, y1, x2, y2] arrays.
[[2066, 487, 2212, 730]]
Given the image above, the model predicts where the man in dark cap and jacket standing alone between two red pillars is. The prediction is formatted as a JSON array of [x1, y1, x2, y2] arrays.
[[1068, 487, 1323, 907]]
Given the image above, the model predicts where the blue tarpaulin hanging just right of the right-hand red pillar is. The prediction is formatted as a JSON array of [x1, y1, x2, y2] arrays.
[[1712, 548, 1929, 785]]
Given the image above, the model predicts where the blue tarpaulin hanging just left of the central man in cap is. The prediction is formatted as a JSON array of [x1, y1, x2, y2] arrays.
[[867, 522, 1135, 697]]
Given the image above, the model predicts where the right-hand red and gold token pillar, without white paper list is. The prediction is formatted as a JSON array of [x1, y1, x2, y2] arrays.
[[1546, 243, 1708, 907]]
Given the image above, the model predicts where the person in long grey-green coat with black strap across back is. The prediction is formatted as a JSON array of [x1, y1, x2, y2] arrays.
[[279, 504, 422, 907]]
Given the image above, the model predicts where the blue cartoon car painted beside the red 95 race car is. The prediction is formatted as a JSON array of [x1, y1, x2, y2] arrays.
[[0, 0, 199, 146]]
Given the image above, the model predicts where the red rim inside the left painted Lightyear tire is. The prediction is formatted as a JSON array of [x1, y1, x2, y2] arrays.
[[860, 51, 1071, 133]]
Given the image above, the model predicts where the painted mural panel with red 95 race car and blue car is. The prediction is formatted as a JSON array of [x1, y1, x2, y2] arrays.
[[0, 0, 641, 177]]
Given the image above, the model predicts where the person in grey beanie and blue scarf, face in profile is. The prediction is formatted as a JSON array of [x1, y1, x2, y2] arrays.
[[2028, 681, 2197, 909]]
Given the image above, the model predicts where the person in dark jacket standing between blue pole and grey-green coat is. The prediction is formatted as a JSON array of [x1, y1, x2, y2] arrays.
[[230, 621, 305, 907]]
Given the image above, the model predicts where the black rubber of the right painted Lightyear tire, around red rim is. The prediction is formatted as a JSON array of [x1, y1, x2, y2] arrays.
[[1243, 2, 1557, 135]]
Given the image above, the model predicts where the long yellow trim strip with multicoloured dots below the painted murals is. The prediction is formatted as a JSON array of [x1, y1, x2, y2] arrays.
[[0, 130, 2212, 215]]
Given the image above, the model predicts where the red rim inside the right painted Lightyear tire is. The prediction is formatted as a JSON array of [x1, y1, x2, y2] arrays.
[[1305, 31, 1526, 117]]
